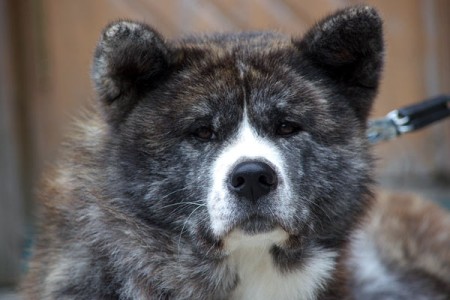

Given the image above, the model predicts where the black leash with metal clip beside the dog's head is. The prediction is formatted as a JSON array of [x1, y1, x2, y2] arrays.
[[367, 95, 450, 144]]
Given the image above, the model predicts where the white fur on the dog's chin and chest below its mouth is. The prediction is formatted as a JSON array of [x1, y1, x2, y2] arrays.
[[225, 229, 336, 300]]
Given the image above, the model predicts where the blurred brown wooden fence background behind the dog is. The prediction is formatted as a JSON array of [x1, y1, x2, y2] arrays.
[[0, 0, 450, 299]]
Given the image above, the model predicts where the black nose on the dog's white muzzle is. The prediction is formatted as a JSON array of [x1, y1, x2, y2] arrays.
[[230, 161, 278, 202]]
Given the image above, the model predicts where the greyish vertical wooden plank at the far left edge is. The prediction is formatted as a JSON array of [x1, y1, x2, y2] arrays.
[[0, 0, 24, 285]]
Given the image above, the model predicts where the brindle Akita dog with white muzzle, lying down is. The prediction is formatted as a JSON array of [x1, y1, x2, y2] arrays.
[[23, 6, 450, 300]]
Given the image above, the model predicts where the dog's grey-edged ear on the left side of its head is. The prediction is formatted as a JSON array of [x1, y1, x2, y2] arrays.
[[92, 21, 170, 125]]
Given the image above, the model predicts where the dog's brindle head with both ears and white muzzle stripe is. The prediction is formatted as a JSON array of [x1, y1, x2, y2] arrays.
[[93, 7, 382, 253]]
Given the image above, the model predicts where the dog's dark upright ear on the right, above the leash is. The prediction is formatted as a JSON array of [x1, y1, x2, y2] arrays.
[[293, 6, 384, 121]]
